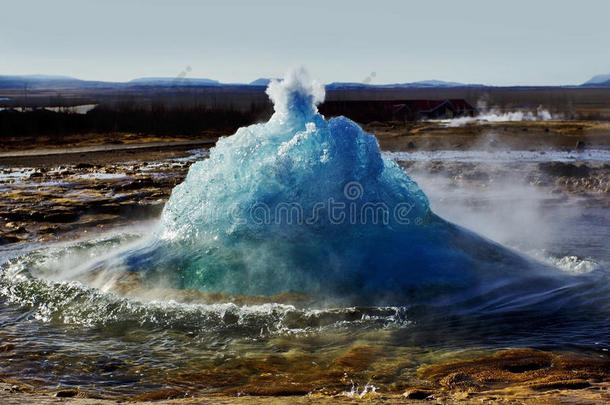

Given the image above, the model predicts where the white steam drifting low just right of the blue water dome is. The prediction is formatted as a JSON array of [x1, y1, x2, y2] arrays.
[[407, 163, 603, 274]]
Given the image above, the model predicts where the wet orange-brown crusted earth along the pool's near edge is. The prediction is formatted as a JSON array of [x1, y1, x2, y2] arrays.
[[0, 346, 610, 404]]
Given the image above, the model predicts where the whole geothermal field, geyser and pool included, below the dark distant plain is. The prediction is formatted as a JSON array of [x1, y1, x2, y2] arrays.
[[0, 70, 610, 403]]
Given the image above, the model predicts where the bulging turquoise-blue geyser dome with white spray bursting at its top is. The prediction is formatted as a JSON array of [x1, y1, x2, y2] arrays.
[[98, 71, 548, 303]]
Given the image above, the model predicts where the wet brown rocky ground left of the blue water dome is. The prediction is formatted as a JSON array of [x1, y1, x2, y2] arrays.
[[0, 144, 205, 244]]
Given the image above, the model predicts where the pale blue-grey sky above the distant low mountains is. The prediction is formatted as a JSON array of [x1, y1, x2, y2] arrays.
[[0, 0, 610, 86]]
